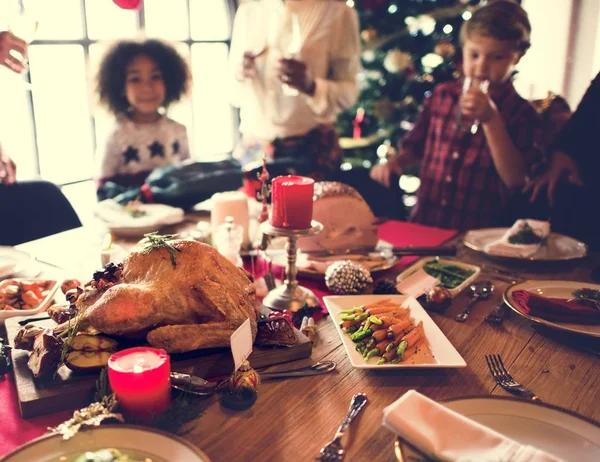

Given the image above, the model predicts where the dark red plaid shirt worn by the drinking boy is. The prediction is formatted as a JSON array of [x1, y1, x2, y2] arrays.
[[401, 81, 542, 230]]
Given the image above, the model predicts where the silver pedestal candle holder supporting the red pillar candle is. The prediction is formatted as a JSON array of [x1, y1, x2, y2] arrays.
[[260, 220, 323, 312]]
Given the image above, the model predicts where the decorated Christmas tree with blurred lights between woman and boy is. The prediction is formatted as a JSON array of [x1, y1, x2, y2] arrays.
[[336, 0, 486, 166]]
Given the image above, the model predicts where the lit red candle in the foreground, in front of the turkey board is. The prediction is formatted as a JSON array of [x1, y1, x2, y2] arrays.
[[108, 347, 171, 420]]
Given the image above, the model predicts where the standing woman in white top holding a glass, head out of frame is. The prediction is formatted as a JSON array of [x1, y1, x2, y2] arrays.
[[230, 0, 360, 179]]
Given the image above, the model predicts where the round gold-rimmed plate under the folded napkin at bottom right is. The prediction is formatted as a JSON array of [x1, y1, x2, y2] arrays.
[[394, 397, 600, 462]]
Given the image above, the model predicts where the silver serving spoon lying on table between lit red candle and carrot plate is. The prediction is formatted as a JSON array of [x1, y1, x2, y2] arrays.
[[171, 361, 337, 396]]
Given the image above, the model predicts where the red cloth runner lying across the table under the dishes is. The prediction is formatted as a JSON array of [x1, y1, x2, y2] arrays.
[[0, 221, 456, 457]]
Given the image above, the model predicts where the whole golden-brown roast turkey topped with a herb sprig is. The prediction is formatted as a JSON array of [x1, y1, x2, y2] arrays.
[[55, 240, 258, 353]]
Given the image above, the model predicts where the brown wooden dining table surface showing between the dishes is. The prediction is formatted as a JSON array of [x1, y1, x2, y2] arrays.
[[1, 218, 600, 462]]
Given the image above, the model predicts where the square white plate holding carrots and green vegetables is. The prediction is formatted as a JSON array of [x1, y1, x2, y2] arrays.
[[323, 295, 467, 369]]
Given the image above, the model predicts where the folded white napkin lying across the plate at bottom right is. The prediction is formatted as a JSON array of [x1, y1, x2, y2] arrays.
[[382, 390, 561, 462]]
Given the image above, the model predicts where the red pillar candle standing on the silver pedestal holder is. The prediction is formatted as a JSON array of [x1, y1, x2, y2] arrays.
[[271, 175, 315, 229]]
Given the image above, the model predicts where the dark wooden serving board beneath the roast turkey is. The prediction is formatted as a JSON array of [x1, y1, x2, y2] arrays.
[[5, 316, 312, 418]]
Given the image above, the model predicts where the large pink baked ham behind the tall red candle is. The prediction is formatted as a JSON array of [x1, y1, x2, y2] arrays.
[[298, 181, 378, 252]]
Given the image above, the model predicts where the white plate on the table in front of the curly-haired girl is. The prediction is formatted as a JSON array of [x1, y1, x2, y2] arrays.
[[94, 200, 185, 237]]
